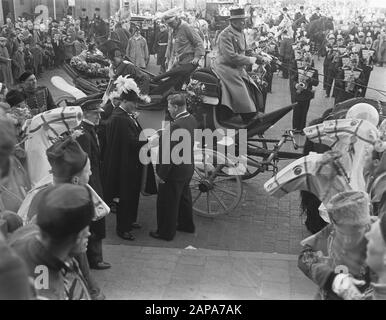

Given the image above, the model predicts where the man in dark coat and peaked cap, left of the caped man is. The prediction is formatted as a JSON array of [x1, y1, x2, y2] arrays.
[[77, 100, 111, 270]]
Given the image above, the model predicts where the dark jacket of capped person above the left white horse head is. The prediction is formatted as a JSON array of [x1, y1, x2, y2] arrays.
[[22, 86, 57, 115]]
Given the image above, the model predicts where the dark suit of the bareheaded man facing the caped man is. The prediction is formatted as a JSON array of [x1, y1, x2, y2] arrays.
[[157, 112, 197, 240]]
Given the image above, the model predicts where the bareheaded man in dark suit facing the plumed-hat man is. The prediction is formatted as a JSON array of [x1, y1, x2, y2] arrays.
[[150, 94, 197, 241]]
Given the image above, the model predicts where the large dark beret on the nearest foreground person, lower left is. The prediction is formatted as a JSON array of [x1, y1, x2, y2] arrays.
[[36, 183, 95, 239]]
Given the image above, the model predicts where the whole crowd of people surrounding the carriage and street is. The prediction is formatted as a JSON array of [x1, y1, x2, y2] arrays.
[[0, 1, 386, 300]]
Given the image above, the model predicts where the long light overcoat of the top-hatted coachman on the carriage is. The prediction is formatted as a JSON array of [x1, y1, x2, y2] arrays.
[[213, 26, 262, 113]]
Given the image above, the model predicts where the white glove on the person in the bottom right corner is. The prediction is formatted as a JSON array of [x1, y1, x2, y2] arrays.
[[332, 273, 365, 300]]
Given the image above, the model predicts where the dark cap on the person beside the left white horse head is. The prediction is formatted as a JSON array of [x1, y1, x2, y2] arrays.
[[46, 136, 88, 179]]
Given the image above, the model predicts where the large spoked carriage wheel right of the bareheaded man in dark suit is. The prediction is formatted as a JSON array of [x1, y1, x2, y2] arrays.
[[190, 149, 243, 217]]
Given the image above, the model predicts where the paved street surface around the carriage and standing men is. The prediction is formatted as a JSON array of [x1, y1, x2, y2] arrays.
[[39, 58, 386, 299]]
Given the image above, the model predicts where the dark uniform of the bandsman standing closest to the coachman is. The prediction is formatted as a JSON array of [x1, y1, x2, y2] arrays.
[[292, 62, 319, 130]]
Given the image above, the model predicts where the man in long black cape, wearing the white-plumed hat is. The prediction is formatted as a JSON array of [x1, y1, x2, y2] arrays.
[[103, 90, 150, 240]]
